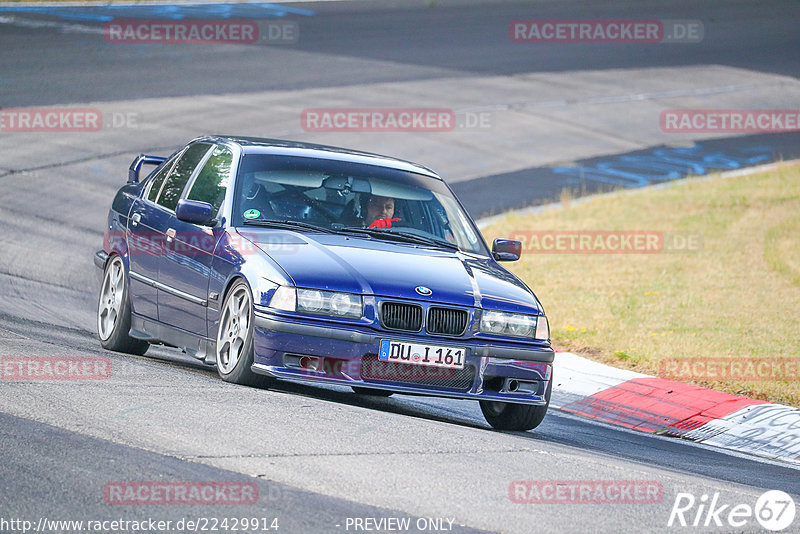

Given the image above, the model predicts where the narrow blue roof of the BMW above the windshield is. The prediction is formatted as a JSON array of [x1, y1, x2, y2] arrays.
[[194, 135, 441, 180]]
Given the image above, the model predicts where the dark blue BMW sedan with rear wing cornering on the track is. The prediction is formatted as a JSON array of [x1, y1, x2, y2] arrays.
[[94, 136, 554, 430]]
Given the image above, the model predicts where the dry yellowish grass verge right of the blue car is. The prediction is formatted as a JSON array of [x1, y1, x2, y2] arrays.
[[483, 165, 800, 407]]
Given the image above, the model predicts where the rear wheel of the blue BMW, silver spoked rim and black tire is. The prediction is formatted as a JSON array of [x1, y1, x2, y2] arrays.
[[97, 255, 150, 355]]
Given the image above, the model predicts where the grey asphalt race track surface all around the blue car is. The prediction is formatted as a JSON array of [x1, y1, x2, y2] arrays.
[[0, 1, 800, 533]]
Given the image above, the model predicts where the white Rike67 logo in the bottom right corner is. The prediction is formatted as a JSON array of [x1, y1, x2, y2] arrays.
[[667, 490, 796, 532]]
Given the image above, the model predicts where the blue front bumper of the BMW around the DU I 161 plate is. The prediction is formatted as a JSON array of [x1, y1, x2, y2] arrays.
[[252, 310, 554, 405]]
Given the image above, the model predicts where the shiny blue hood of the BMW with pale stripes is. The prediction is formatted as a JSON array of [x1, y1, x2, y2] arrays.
[[243, 228, 541, 314]]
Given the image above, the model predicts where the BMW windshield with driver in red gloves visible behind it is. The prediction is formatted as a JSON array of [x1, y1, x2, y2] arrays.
[[228, 154, 488, 254]]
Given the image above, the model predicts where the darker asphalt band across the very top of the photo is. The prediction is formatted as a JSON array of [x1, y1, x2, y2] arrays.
[[0, 0, 800, 107]]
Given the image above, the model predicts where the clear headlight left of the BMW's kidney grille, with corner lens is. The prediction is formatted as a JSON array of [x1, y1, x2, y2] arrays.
[[269, 286, 364, 319]]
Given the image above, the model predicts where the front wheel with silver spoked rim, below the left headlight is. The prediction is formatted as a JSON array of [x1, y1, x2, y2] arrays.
[[216, 280, 266, 386]]
